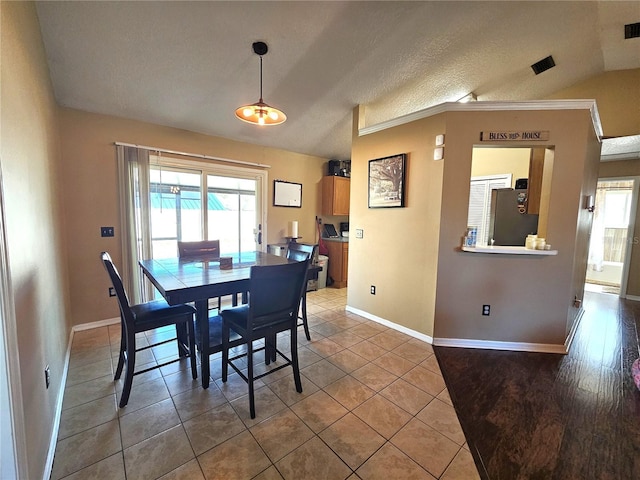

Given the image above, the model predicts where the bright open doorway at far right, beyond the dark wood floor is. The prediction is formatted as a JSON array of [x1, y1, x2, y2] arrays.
[[585, 177, 638, 297]]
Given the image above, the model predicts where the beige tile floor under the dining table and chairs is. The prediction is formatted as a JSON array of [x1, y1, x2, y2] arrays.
[[51, 289, 479, 480]]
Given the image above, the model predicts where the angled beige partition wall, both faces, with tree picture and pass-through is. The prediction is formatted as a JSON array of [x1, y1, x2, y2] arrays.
[[348, 109, 599, 345]]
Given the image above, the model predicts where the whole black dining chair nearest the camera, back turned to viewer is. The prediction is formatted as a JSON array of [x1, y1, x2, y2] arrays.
[[220, 260, 309, 418]]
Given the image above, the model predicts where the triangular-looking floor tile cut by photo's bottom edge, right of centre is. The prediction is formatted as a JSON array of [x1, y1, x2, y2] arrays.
[[356, 443, 434, 480]]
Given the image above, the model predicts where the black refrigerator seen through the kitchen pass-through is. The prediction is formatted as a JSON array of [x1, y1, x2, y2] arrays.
[[489, 188, 538, 247]]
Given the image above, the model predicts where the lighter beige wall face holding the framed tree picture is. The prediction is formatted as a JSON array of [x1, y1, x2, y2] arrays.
[[347, 111, 448, 336]]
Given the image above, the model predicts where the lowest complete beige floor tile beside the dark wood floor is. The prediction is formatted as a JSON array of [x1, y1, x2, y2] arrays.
[[391, 418, 460, 478]]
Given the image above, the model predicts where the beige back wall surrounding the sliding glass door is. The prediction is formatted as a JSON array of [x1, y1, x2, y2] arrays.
[[60, 109, 326, 325]]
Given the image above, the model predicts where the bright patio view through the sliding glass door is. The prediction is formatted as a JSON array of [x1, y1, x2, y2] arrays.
[[149, 157, 263, 258]]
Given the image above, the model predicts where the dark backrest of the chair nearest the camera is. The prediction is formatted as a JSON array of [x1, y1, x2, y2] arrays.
[[247, 260, 309, 329]]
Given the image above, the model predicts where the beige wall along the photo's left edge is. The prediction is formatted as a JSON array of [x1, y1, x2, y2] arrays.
[[0, 2, 70, 478]]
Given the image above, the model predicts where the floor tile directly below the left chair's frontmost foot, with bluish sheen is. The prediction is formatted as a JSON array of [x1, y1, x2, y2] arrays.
[[120, 398, 180, 448]]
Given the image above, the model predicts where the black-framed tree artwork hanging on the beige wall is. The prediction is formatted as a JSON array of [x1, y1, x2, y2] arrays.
[[369, 153, 407, 208]]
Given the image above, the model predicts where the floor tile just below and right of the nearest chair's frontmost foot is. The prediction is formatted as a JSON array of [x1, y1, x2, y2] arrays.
[[250, 409, 313, 462]]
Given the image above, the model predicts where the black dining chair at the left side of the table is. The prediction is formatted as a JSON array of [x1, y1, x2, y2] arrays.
[[100, 252, 198, 408]]
